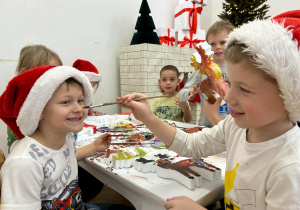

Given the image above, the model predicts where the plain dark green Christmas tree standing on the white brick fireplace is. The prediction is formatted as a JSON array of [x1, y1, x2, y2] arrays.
[[130, 0, 160, 45]]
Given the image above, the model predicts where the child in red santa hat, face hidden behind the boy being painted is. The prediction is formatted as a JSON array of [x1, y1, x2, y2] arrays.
[[73, 59, 102, 116]]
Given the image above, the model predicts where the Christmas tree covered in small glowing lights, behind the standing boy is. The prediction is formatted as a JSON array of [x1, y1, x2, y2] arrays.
[[218, 0, 270, 27]]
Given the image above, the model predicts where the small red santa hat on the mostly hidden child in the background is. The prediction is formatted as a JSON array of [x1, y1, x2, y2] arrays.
[[73, 59, 102, 82]]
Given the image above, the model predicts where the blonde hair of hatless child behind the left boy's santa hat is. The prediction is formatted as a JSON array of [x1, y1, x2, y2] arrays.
[[16, 45, 63, 75]]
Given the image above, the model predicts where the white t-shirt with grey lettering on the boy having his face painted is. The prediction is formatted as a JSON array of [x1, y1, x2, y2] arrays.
[[0, 134, 84, 210]]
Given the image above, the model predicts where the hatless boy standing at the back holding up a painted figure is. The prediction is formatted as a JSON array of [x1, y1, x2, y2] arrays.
[[178, 20, 234, 127]]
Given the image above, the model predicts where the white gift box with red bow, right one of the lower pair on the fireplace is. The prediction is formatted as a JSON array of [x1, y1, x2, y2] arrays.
[[177, 30, 205, 48]]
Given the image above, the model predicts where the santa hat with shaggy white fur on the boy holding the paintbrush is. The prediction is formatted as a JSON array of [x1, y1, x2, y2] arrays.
[[227, 10, 300, 122]]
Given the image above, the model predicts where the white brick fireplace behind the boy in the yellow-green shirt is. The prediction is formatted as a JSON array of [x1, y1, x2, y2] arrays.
[[119, 44, 201, 124]]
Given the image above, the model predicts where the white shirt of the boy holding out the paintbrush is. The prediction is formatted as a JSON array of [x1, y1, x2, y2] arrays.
[[169, 116, 300, 210]]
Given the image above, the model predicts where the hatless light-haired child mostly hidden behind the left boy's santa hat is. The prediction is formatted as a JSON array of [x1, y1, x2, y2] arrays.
[[7, 44, 63, 153]]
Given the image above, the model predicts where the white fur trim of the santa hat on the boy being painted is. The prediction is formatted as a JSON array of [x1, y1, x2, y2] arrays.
[[17, 66, 93, 136]]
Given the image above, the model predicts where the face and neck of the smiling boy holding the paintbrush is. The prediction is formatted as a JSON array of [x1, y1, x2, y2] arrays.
[[225, 62, 289, 141]]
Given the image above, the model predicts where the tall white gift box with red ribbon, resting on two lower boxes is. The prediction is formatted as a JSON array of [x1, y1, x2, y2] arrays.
[[174, 1, 202, 33]]
